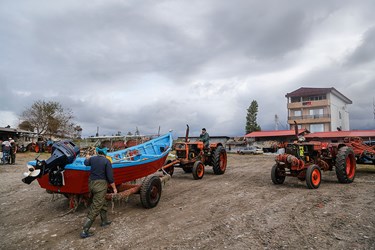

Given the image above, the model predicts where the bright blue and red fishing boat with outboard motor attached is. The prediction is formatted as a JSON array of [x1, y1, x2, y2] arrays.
[[23, 132, 173, 207]]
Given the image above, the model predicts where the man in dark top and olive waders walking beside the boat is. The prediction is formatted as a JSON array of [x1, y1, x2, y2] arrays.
[[81, 148, 117, 238]]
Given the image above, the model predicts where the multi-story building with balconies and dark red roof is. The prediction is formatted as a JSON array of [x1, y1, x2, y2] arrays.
[[285, 87, 352, 132]]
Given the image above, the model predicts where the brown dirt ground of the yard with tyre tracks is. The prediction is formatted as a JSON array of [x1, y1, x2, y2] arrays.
[[0, 153, 375, 250]]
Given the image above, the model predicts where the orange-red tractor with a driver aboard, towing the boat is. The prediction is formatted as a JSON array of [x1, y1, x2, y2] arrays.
[[163, 125, 227, 180]]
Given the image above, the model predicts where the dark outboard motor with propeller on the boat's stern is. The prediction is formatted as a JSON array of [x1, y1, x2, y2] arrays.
[[22, 140, 79, 186]]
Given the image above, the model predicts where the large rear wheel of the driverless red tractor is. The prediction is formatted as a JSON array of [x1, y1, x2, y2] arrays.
[[336, 147, 356, 183]]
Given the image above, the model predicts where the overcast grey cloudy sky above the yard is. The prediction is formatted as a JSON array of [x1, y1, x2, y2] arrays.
[[0, 0, 375, 136]]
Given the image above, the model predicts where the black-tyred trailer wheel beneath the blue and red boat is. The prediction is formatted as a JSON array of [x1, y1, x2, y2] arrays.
[[140, 175, 161, 208]]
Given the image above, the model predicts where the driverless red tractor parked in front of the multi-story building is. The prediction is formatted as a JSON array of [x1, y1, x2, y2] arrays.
[[271, 122, 356, 189]]
